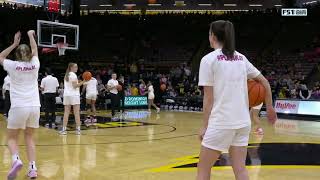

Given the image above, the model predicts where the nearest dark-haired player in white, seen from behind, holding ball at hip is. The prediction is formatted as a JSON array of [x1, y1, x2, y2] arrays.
[[197, 21, 277, 180]]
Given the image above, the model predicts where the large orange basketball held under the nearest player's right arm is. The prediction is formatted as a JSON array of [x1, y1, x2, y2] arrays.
[[248, 80, 266, 107]]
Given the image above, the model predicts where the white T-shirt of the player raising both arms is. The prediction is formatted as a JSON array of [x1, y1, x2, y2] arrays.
[[3, 56, 40, 108]]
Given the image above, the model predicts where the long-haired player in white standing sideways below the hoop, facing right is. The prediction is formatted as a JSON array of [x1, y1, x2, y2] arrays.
[[59, 63, 86, 135]]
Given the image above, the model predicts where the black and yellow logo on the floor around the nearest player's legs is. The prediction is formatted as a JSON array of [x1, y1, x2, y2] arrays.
[[147, 143, 320, 172]]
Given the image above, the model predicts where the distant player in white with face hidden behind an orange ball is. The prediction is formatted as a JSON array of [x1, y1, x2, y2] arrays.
[[82, 77, 98, 123]]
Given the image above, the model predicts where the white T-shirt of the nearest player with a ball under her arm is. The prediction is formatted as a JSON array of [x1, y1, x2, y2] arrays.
[[199, 49, 260, 129]]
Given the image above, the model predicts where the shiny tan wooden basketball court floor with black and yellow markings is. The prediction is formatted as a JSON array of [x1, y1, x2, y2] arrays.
[[0, 110, 320, 180]]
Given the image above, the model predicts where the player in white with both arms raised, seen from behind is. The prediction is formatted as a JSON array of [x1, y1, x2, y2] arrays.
[[0, 30, 40, 179]]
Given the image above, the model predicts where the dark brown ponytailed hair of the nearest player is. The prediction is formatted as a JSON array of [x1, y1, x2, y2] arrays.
[[210, 20, 235, 58]]
